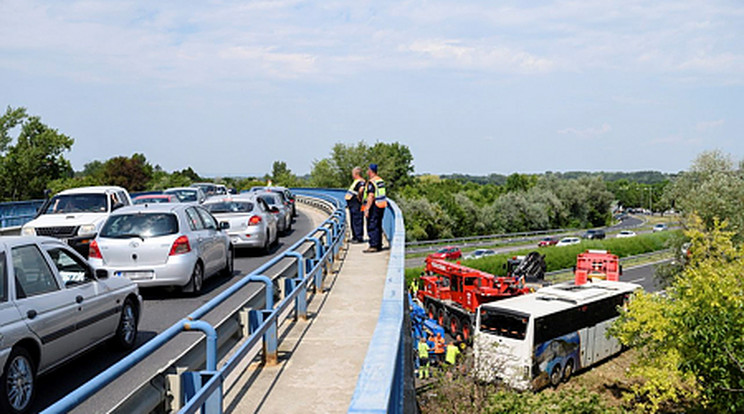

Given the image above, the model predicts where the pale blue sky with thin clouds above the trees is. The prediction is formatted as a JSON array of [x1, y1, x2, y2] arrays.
[[0, 0, 744, 175]]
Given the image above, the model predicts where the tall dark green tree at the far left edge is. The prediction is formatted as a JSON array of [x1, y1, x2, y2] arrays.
[[0, 107, 74, 200]]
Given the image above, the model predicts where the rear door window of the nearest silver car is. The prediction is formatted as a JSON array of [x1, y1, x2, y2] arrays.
[[11, 245, 60, 299]]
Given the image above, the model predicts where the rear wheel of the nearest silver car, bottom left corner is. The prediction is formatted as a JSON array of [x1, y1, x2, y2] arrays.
[[0, 347, 36, 414]]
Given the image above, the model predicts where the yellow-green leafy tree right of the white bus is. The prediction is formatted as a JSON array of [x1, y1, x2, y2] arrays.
[[613, 215, 744, 412]]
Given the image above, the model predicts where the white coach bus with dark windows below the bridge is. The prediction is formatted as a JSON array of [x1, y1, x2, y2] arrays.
[[474, 280, 641, 390]]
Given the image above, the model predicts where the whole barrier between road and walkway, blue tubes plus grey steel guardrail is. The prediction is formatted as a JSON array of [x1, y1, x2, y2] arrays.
[[42, 190, 346, 414]]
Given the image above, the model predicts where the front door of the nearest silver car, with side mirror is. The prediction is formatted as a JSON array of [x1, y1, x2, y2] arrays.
[[44, 245, 121, 343]]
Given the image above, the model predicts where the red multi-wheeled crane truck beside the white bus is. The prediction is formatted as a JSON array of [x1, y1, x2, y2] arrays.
[[417, 257, 530, 340]]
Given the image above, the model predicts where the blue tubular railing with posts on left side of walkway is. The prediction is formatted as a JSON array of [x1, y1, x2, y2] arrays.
[[42, 190, 346, 414]]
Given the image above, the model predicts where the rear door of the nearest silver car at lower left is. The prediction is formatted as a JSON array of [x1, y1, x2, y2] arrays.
[[10, 243, 83, 370]]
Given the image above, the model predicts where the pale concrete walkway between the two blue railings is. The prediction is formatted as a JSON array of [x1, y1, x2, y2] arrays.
[[224, 238, 390, 414]]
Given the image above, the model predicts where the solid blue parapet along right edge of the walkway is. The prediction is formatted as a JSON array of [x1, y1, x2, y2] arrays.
[[348, 199, 409, 413]]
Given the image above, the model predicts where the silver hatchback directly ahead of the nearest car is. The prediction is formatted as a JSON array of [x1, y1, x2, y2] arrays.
[[89, 204, 234, 295]]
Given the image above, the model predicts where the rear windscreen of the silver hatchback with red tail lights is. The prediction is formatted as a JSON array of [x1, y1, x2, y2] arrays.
[[101, 213, 178, 239]]
